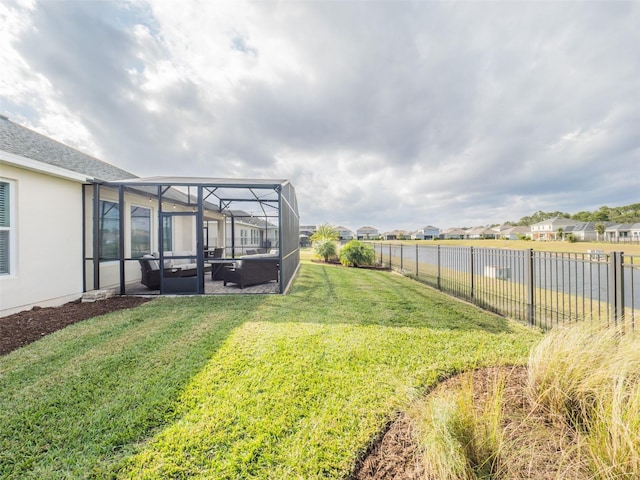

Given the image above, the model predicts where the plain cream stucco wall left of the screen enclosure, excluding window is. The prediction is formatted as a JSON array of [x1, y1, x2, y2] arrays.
[[0, 163, 82, 316]]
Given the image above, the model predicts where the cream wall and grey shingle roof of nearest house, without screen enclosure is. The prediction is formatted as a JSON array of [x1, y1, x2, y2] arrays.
[[0, 116, 136, 315]]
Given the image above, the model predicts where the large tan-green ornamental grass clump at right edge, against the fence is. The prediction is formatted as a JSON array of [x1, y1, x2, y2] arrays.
[[528, 322, 640, 479]]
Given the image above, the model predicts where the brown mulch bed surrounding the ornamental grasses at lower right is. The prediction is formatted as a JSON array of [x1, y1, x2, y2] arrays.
[[350, 367, 576, 480]]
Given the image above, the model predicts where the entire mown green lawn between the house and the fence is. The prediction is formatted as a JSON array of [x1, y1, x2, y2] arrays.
[[0, 261, 541, 479]]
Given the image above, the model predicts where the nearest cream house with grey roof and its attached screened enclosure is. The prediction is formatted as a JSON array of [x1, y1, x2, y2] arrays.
[[0, 116, 299, 316]]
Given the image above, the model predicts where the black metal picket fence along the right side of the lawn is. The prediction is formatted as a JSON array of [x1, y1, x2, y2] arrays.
[[373, 243, 640, 330]]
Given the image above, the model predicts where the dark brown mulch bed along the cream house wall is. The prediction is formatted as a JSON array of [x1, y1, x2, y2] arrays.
[[0, 296, 151, 355]]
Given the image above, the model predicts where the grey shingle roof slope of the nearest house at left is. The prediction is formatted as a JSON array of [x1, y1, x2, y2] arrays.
[[0, 115, 136, 181]]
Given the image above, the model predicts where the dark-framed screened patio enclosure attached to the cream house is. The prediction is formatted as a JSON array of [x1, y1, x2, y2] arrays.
[[83, 177, 300, 295]]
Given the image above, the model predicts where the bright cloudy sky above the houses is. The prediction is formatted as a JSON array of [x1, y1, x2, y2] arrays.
[[0, 0, 640, 232]]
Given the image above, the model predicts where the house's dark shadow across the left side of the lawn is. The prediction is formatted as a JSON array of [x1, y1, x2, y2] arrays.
[[0, 295, 267, 478]]
